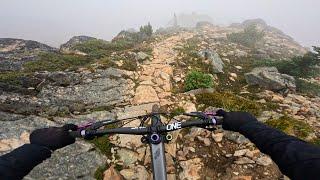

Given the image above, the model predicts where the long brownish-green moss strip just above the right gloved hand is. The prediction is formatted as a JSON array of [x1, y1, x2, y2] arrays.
[[196, 92, 269, 116]]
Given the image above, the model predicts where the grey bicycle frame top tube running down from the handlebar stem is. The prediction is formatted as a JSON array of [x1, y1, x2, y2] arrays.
[[149, 105, 167, 180]]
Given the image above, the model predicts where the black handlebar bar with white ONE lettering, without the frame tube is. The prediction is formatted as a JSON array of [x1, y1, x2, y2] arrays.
[[70, 112, 223, 138]]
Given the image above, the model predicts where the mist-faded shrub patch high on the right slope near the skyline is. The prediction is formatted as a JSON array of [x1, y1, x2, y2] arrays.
[[227, 24, 264, 48]]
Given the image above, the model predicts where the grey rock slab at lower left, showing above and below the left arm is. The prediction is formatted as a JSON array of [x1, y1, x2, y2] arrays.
[[0, 114, 106, 179]]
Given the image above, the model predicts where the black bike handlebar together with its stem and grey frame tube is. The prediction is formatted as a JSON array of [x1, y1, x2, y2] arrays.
[[70, 110, 223, 180]]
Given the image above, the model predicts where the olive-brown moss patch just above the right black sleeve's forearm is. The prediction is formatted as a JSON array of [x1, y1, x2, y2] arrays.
[[266, 116, 313, 139]]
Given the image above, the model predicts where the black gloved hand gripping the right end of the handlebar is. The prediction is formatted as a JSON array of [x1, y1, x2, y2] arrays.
[[217, 109, 257, 132]]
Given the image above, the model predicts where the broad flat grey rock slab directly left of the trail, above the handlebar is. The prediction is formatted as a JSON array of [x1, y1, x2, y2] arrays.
[[39, 73, 134, 107]]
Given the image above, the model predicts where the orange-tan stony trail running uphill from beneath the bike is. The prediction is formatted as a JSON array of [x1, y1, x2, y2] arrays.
[[105, 32, 281, 180]]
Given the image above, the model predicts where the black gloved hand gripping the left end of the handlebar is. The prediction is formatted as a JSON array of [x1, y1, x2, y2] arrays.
[[30, 124, 77, 151]]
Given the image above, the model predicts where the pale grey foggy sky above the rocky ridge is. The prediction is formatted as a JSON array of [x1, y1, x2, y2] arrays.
[[0, 0, 320, 46]]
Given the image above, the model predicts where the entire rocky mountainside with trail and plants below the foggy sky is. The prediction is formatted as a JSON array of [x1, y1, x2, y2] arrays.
[[0, 16, 320, 179]]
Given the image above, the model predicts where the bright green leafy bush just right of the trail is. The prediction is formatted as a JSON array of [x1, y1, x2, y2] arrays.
[[184, 70, 213, 91]]
